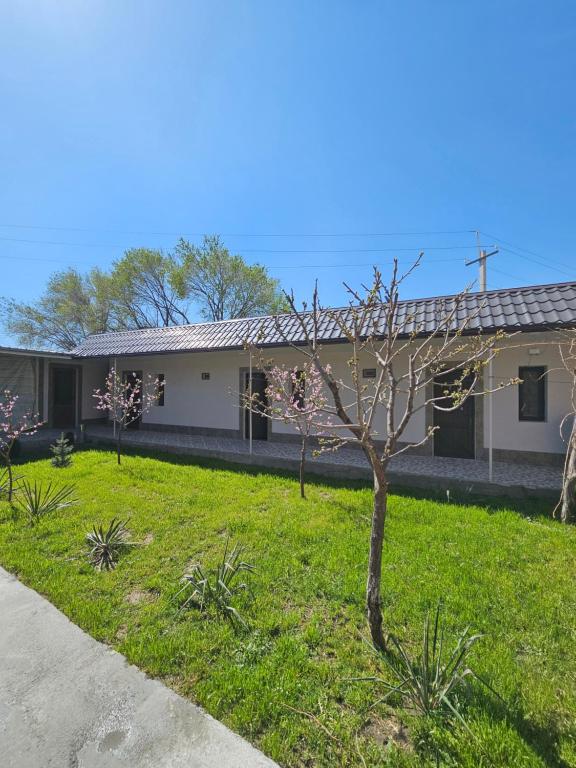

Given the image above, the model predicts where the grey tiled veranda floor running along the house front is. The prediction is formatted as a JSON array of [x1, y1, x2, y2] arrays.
[[88, 426, 562, 495]]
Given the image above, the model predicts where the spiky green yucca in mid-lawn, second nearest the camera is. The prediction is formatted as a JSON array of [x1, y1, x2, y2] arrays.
[[176, 542, 255, 628]]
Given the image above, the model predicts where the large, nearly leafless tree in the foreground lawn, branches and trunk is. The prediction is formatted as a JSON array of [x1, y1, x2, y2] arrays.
[[256, 256, 517, 650]]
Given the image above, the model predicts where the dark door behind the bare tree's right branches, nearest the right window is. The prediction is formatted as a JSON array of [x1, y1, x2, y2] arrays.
[[434, 372, 475, 459]]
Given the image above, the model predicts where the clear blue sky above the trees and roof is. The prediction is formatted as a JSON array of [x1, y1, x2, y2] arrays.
[[0, 0, 576, 342]]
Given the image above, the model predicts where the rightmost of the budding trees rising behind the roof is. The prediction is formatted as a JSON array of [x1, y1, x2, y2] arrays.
[[173, 235, 287, 320]]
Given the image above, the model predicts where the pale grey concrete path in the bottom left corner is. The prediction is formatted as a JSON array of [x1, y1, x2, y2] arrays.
[[0, 568, 276, 768]]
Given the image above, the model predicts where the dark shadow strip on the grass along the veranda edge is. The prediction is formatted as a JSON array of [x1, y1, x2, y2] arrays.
[[14, 443, 556, 520]]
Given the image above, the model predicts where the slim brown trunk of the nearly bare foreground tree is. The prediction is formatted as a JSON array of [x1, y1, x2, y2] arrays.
[[366, 464, 388, 651]]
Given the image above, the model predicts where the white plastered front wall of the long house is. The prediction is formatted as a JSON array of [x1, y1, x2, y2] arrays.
[[101, 333, 570, 454]]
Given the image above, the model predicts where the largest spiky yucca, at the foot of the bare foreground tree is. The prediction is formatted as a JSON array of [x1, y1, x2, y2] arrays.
[[356, 603, 497, 730]]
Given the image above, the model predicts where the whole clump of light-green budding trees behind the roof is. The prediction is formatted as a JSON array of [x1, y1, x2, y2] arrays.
[[0, 236, 286, 351]]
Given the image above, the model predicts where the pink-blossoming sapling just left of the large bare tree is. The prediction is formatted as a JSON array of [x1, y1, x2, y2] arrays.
[[253, 361, 332, 499]]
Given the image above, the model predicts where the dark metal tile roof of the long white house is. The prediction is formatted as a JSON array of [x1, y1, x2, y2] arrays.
[[72, 282, 576, 357]]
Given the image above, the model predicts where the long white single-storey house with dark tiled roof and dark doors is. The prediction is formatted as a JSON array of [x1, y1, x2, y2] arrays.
[[0, 282, 576, 464]]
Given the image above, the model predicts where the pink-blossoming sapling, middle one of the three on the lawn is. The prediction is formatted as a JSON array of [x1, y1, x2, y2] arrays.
[[92, 367, 159, 464]]
